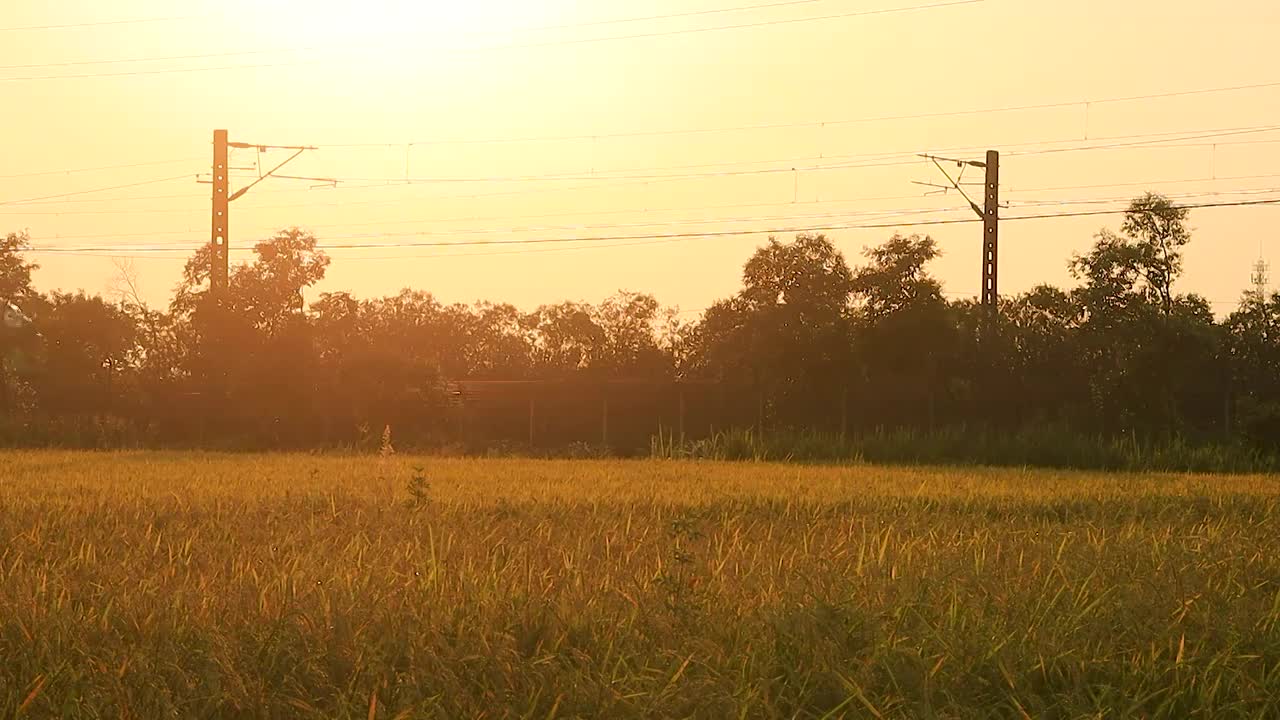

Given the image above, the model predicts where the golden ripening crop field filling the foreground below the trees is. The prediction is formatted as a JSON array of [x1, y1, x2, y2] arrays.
[[0, 452, 1280, 720]]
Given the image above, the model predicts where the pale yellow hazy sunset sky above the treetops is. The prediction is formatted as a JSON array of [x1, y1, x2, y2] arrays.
[[0, 0, 1280, 313]]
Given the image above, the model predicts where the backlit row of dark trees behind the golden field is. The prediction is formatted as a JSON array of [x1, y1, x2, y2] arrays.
[[0, 195, 1280, 452]]
